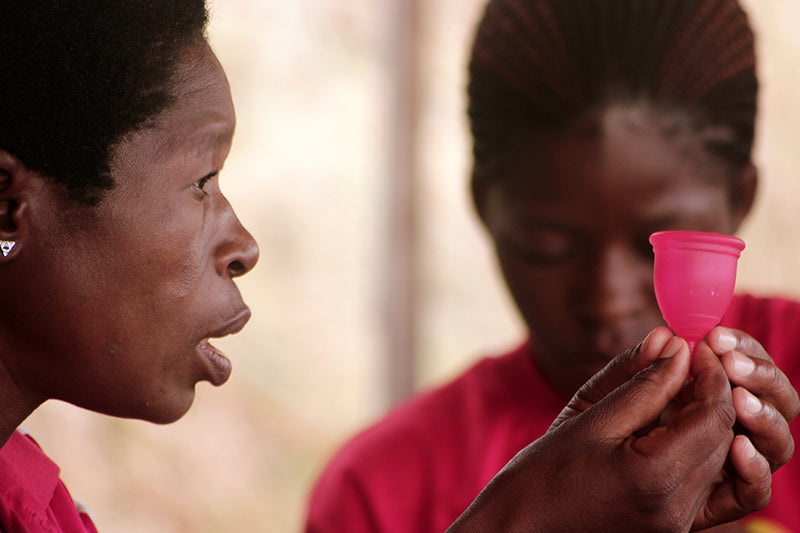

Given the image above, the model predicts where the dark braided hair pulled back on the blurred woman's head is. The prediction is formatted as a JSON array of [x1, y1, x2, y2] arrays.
[[468, 0, 758, 189]]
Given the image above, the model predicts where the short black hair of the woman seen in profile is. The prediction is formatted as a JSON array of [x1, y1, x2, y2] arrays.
[[0, 0, 208, 205]]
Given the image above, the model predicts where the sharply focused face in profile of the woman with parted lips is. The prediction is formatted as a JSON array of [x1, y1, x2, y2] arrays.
[[12, 43, 258, 422]]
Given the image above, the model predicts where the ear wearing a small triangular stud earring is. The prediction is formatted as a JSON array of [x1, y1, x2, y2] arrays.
[[0, 149, 38, 263]]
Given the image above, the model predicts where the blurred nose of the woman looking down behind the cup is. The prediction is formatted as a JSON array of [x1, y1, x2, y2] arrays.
[[584, 239, 653, 324]]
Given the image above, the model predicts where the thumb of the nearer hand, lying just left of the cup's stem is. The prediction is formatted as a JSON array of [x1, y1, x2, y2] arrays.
[[586, 337, 690, 440]]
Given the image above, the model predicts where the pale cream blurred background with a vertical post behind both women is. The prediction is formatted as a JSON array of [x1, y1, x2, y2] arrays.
[[25, 0, 800, 533]]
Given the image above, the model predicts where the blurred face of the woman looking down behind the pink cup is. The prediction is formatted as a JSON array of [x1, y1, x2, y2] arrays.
[[483, 107, 738, 395]]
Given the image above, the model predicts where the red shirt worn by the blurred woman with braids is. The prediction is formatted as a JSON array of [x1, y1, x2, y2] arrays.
[[306, 296, 800, 533]]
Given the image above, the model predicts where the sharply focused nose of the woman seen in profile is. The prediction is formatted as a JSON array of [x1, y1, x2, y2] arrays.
[[215, 195, 259, 278]]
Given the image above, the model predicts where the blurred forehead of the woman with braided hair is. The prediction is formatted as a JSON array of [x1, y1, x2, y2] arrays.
[[501, 105, 730, 203]]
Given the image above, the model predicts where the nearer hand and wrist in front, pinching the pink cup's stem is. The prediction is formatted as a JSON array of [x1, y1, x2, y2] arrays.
[[449, 327, 771, 532]]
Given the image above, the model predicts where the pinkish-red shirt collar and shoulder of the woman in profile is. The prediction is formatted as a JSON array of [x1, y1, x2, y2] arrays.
[[0, 431, 97, 533]]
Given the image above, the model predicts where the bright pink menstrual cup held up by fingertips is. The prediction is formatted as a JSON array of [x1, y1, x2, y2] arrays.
[[650, 231, 744, 353]]
